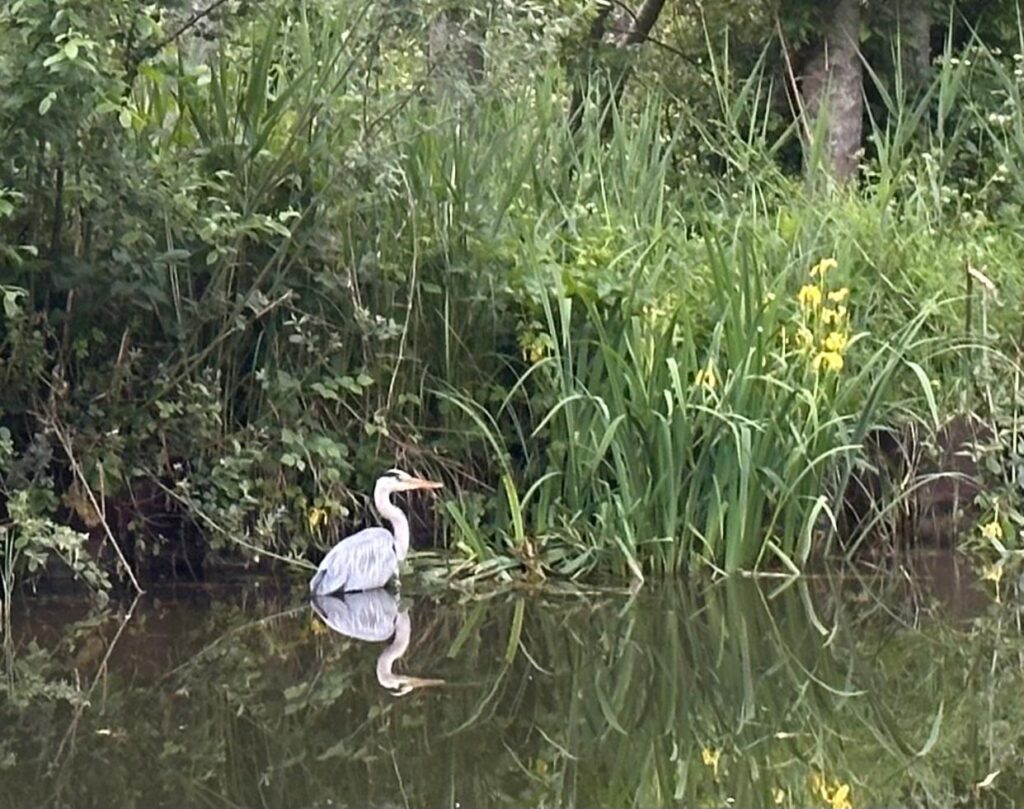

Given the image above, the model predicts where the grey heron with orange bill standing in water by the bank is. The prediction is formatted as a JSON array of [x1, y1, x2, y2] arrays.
[[309, 469, 442, 596]]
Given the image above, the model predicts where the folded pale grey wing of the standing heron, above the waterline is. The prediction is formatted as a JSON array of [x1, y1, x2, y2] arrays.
[[309, 527, 398, 595]]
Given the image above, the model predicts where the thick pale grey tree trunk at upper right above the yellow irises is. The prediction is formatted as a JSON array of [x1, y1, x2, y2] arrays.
[[802, 0, 864, 181]]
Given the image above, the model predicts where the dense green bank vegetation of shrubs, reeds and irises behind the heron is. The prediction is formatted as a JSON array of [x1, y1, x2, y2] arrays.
[[0, 0, 1024, 586]]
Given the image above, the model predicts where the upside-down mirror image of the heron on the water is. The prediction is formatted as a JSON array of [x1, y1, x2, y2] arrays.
[[312, 589, 444, 696]]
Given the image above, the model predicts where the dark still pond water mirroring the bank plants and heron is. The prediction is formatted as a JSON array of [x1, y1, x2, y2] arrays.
[[0, 556, 1024, 807]]
